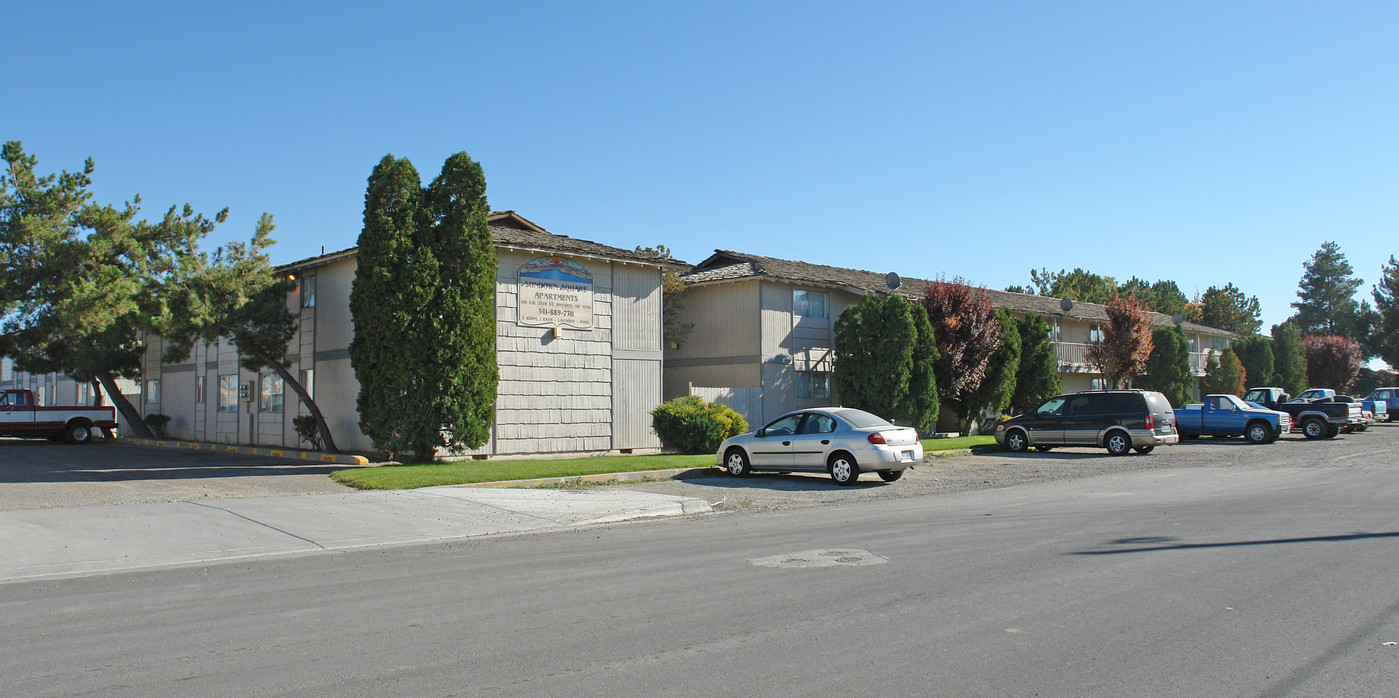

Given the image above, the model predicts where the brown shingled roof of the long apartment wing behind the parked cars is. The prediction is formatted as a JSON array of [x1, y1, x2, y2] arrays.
[[680, 250, 1235, 337]]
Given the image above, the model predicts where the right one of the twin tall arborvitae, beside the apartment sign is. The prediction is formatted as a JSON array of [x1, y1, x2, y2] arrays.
[[418, 152, 499, 456]]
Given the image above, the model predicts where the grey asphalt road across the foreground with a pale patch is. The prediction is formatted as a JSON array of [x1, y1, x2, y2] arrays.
[[0, 432, 1399, 695]]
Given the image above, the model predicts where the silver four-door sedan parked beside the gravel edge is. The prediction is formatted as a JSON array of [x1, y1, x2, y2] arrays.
[[716, 407, 923, 485]]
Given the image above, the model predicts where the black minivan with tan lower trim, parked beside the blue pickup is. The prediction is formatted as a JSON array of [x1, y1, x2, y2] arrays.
[[996, 390, 1181, 456]]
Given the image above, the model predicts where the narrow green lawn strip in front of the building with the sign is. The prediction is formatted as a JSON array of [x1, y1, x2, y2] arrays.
[[330, 453, 715, 490]]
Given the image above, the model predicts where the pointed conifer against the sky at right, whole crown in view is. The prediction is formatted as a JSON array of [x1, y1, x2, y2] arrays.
[[1293, 242, 1368, 341]]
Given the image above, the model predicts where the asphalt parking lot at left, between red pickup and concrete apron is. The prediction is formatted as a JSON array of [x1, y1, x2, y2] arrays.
[[0, 438, 351, 511]]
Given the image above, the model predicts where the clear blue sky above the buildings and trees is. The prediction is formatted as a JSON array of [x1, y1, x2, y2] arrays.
[[0, 1, 1399, 338]]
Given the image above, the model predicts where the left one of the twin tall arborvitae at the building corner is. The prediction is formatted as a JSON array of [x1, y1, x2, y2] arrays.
[[350, 155, 436, 453]]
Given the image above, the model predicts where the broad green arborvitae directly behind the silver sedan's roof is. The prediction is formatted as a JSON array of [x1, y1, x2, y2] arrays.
[[832, 294, 918, 415]]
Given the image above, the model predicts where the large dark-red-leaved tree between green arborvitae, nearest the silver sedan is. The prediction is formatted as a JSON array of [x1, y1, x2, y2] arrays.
[[923, 277, 1000, 434]]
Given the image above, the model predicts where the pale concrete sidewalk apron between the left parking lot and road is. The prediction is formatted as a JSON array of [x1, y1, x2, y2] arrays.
[[0, 487, 711, 583]]
